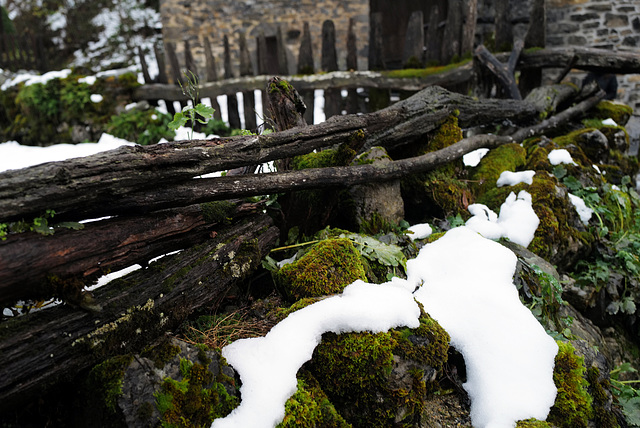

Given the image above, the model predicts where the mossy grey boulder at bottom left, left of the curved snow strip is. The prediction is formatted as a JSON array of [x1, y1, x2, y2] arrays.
[[83, 339, 240, 427]]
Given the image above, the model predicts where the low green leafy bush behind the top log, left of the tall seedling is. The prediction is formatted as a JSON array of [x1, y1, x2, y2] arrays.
[[106, 109, 176, 146]]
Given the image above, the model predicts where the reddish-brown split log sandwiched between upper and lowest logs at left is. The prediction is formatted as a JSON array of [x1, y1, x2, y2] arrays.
[[0, 200, 261, 308]]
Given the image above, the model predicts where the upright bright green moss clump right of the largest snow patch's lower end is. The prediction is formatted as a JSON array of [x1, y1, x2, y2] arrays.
[[547, 341, 594, 428]]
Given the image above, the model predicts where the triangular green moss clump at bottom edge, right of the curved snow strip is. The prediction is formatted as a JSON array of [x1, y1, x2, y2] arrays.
[[277, 370, 351, 428]]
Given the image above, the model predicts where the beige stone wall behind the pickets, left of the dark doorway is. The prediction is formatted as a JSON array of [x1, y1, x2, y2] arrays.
[[160, 0, 369, 78]]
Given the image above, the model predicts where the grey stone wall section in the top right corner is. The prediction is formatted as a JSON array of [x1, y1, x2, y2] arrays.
[[547, 0, 640, 112]]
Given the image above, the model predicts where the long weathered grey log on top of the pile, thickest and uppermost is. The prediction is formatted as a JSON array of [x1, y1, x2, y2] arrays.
[[0, 87, 540, 221]]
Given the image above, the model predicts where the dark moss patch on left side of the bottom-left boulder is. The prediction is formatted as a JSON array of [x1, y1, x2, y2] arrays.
[[86, 355, 133, 413]]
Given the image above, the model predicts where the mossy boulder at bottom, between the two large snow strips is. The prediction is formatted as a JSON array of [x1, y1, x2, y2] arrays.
[[308, 312, 449, 427]]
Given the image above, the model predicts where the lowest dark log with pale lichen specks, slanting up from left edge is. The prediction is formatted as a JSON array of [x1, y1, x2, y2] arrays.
[[0, 214, 278, 413]]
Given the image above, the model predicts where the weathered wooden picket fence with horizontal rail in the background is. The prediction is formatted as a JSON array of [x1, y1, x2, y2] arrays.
[[135, 12, 484, 130]]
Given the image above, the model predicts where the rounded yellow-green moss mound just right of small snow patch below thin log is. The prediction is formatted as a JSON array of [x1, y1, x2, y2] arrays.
[[471, 143, 526, 197]]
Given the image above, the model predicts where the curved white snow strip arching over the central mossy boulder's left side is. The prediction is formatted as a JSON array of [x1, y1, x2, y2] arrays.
[[211, 281, 420, 428]]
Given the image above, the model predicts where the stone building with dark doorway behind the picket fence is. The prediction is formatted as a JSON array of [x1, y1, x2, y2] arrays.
[[160, 0, 640, 109]]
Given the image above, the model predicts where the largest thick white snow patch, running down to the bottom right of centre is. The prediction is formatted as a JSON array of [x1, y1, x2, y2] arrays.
[[407, 227, 558, 428]]
